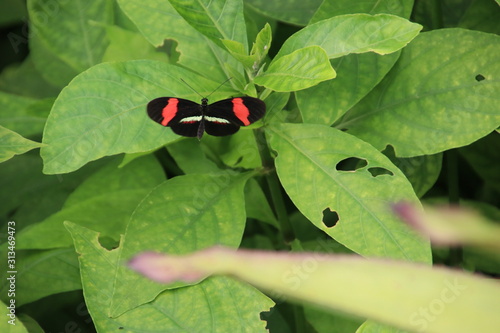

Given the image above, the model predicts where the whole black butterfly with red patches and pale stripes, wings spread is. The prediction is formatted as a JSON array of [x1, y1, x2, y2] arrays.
[[147, 97, 266, 139]]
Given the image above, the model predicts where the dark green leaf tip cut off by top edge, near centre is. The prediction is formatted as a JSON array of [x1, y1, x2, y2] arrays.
[[245, 0, 321, 25]]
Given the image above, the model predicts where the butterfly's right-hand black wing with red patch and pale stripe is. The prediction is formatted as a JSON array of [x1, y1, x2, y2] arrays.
[[205, 97, 266, 136]]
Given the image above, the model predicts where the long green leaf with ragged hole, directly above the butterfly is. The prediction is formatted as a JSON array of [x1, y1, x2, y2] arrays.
[[118, 0, 241, 82]]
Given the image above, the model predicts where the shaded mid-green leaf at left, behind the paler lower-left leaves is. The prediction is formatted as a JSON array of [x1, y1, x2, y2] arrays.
[[17, 156, 165, 249]]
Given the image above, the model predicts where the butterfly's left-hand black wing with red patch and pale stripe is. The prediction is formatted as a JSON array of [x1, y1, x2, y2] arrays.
[[147, 97, 202, 137]]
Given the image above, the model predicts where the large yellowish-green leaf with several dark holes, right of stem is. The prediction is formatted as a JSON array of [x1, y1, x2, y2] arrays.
[[268, 124, 430, 262]]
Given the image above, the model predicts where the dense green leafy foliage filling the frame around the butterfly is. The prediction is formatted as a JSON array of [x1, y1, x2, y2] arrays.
[[0, 0, 500, 333]]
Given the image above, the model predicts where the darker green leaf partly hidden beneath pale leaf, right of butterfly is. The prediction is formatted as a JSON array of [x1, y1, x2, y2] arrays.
[[295, 52, 400, 126]]
